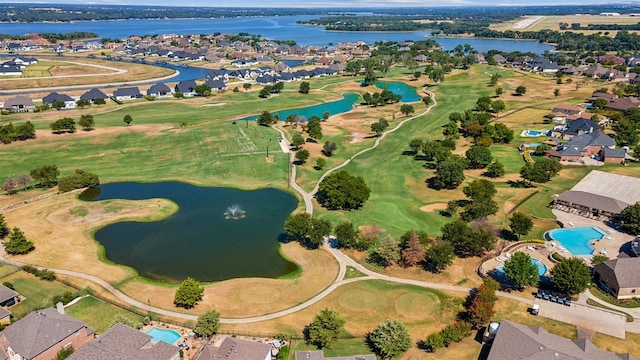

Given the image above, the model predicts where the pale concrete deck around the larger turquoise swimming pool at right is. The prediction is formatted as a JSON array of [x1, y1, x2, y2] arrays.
[[552, 209, 634, 259]]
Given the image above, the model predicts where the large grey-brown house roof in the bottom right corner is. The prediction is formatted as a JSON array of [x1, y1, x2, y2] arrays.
[[487, 320, 635, 360]]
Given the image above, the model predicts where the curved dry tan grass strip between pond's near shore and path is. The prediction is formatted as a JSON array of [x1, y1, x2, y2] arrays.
[[120, 243, 338, 317]]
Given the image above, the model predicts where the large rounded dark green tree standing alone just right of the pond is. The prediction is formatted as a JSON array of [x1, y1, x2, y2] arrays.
[[316, 170, 370, 210]]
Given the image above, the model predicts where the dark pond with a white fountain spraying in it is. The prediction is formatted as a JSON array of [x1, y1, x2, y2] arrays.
[[80, 182, 297, 282]]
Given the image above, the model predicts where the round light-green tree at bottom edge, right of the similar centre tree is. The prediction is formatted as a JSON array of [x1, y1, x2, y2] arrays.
[[367, 319, 411, 359]]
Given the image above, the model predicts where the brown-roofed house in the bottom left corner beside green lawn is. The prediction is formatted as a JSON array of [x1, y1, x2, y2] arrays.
[[0, 303, 94, 360]]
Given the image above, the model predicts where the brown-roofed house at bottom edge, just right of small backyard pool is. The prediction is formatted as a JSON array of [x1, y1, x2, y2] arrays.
[[194, 337, 271, 360]]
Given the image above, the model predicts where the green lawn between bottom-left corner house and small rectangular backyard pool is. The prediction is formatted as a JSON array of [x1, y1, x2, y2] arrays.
[[66, 296, 142, 334]]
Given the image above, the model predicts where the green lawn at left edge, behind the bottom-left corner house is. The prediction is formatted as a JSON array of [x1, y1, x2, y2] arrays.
[[0, 271, 76, 318]]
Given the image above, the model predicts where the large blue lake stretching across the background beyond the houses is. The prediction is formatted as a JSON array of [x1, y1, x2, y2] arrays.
[[0, 15, 553, 54]]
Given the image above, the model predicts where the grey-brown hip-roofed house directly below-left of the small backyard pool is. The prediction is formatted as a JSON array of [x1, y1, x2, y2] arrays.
[[67, 324, 180, 360]]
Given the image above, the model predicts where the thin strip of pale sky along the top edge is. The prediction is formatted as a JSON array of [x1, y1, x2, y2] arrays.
[[0, 0, 634, 8]]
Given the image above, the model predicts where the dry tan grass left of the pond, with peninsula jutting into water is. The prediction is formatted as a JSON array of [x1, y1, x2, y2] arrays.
[[5, 193, 177, 283]]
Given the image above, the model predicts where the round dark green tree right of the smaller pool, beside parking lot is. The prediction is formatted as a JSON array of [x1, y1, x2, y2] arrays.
[[551, 258, 591, 295]]
